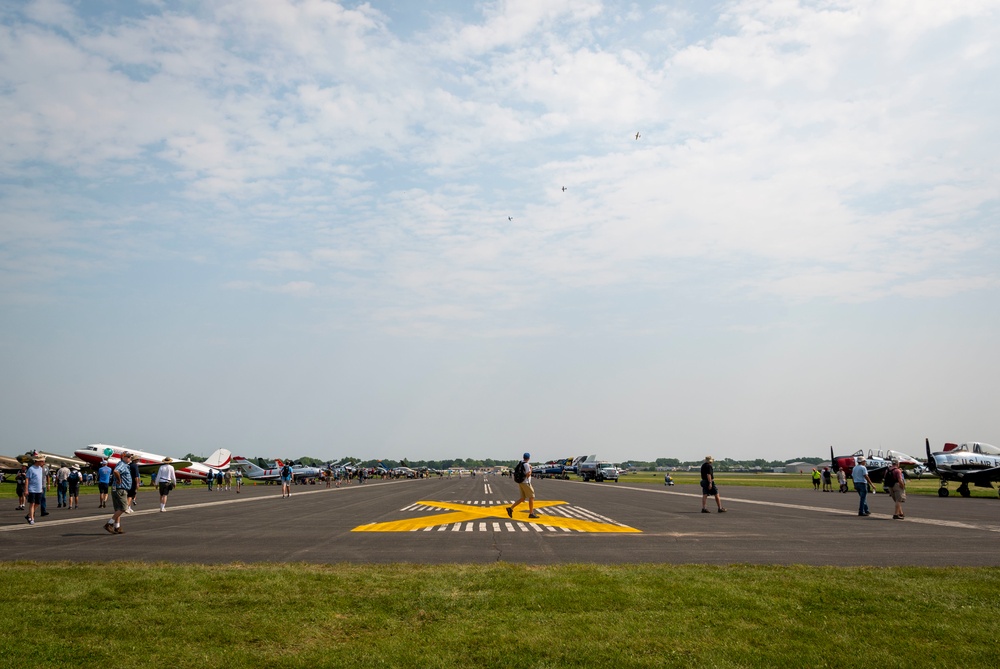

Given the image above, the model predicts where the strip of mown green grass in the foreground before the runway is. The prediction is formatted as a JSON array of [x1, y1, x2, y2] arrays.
[[0, 563, 1000, 669]]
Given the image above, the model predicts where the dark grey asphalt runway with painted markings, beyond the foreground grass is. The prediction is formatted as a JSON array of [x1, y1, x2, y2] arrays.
[[0, 476, 1000, 566]]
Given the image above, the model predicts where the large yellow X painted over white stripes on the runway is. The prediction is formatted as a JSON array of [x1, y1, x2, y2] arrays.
[[351, 500, 641, 532]]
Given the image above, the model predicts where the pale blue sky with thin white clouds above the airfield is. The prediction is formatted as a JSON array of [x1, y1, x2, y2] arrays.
[[0, 0, 1000, 461]]
